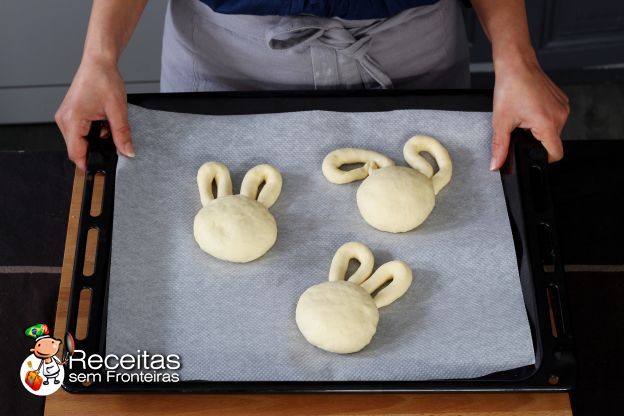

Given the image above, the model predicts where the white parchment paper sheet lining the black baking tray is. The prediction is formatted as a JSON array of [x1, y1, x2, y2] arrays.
[[106, 106, 535, 381]]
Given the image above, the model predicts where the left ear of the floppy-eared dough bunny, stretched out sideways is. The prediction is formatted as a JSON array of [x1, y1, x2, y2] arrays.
[[322, 147, 394, 185]]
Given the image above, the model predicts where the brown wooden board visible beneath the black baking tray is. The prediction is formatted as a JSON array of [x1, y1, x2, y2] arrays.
[[45, 171, 572, 416]]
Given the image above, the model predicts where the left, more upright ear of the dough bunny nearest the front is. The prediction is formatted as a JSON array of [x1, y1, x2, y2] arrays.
[[329, 241, 375, 285]]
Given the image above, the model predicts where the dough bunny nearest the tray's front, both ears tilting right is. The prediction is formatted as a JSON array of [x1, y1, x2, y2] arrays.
[[295, 242, 412, 354]]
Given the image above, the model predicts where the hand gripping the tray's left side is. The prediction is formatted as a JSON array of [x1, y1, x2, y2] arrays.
[[54, 62, 134, 171]]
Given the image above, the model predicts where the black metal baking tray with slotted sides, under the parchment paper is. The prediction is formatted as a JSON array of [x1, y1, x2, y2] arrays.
[[63, 90, 575, 393]]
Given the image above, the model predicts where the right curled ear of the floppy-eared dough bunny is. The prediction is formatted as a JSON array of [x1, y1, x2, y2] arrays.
[[403, 136, 453, 195]]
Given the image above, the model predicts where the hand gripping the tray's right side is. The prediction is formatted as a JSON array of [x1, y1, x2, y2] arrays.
[[490, 54, 570, 170]]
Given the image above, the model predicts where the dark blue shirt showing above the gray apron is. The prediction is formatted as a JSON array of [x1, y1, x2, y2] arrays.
[[201, 0, 438, 20]]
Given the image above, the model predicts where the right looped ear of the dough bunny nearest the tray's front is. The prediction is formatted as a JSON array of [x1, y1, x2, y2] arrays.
[[360, 260, 412, 308]]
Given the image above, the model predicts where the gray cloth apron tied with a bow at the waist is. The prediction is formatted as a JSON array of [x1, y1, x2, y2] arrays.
[[160, 0, 470, 92]]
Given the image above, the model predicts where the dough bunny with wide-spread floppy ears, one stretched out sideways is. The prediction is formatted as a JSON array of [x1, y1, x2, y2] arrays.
[[323, 136, 453, 233]]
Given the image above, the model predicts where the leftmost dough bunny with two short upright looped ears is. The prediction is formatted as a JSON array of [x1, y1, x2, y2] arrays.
[[193, 162, 282, 263]]
